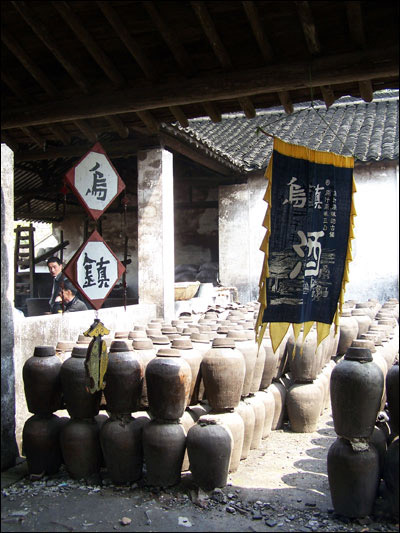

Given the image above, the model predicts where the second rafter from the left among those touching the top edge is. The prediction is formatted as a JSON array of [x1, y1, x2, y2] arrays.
[[52, 0, 125, 87]]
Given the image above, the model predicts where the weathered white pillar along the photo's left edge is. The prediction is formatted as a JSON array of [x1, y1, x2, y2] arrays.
[[1, 144, 18, 470]]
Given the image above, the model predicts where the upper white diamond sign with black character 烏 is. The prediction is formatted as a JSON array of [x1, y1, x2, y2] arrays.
[[65, 143, 125, 220]]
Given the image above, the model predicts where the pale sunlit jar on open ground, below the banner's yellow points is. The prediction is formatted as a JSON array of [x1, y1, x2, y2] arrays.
[[286, 383, 323, 433]]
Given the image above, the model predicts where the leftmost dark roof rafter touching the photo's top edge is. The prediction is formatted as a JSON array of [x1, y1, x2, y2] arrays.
[[11, 0, 89, 93]]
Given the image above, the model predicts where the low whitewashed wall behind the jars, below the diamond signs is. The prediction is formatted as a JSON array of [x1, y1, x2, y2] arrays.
[[13, 304, 156, 451]]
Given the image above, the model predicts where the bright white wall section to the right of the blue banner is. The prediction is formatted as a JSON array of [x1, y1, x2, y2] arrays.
[[345, 161, 399, 303]]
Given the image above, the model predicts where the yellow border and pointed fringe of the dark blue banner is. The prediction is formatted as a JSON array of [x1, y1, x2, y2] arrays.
[[255, 137, 357, 353]]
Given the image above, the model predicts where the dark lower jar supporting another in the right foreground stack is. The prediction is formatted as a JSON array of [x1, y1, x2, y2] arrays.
[[328, 438, 379, 518]]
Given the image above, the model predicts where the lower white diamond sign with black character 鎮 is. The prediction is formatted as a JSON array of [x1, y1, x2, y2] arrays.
[[63, 231, 125, 309]]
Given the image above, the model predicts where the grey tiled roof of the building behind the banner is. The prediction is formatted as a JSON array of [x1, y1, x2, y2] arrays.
[[164, 90, 399, 171]]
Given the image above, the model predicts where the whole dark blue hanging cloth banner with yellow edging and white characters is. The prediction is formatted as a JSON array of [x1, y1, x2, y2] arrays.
[[256, 138, 355, 351]]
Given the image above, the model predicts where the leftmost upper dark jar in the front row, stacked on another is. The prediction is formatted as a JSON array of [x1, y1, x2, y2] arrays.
[[22, 346, 62, 415]]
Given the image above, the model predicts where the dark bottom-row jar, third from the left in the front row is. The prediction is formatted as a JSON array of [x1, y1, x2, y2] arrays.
[[100, 415, 143, 484]]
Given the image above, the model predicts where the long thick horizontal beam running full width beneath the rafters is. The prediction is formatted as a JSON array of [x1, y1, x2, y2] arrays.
[[2, 47, 399, 129]]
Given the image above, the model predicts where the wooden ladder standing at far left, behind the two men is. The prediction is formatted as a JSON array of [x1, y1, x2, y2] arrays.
[[14, 224, 35, 313]]
